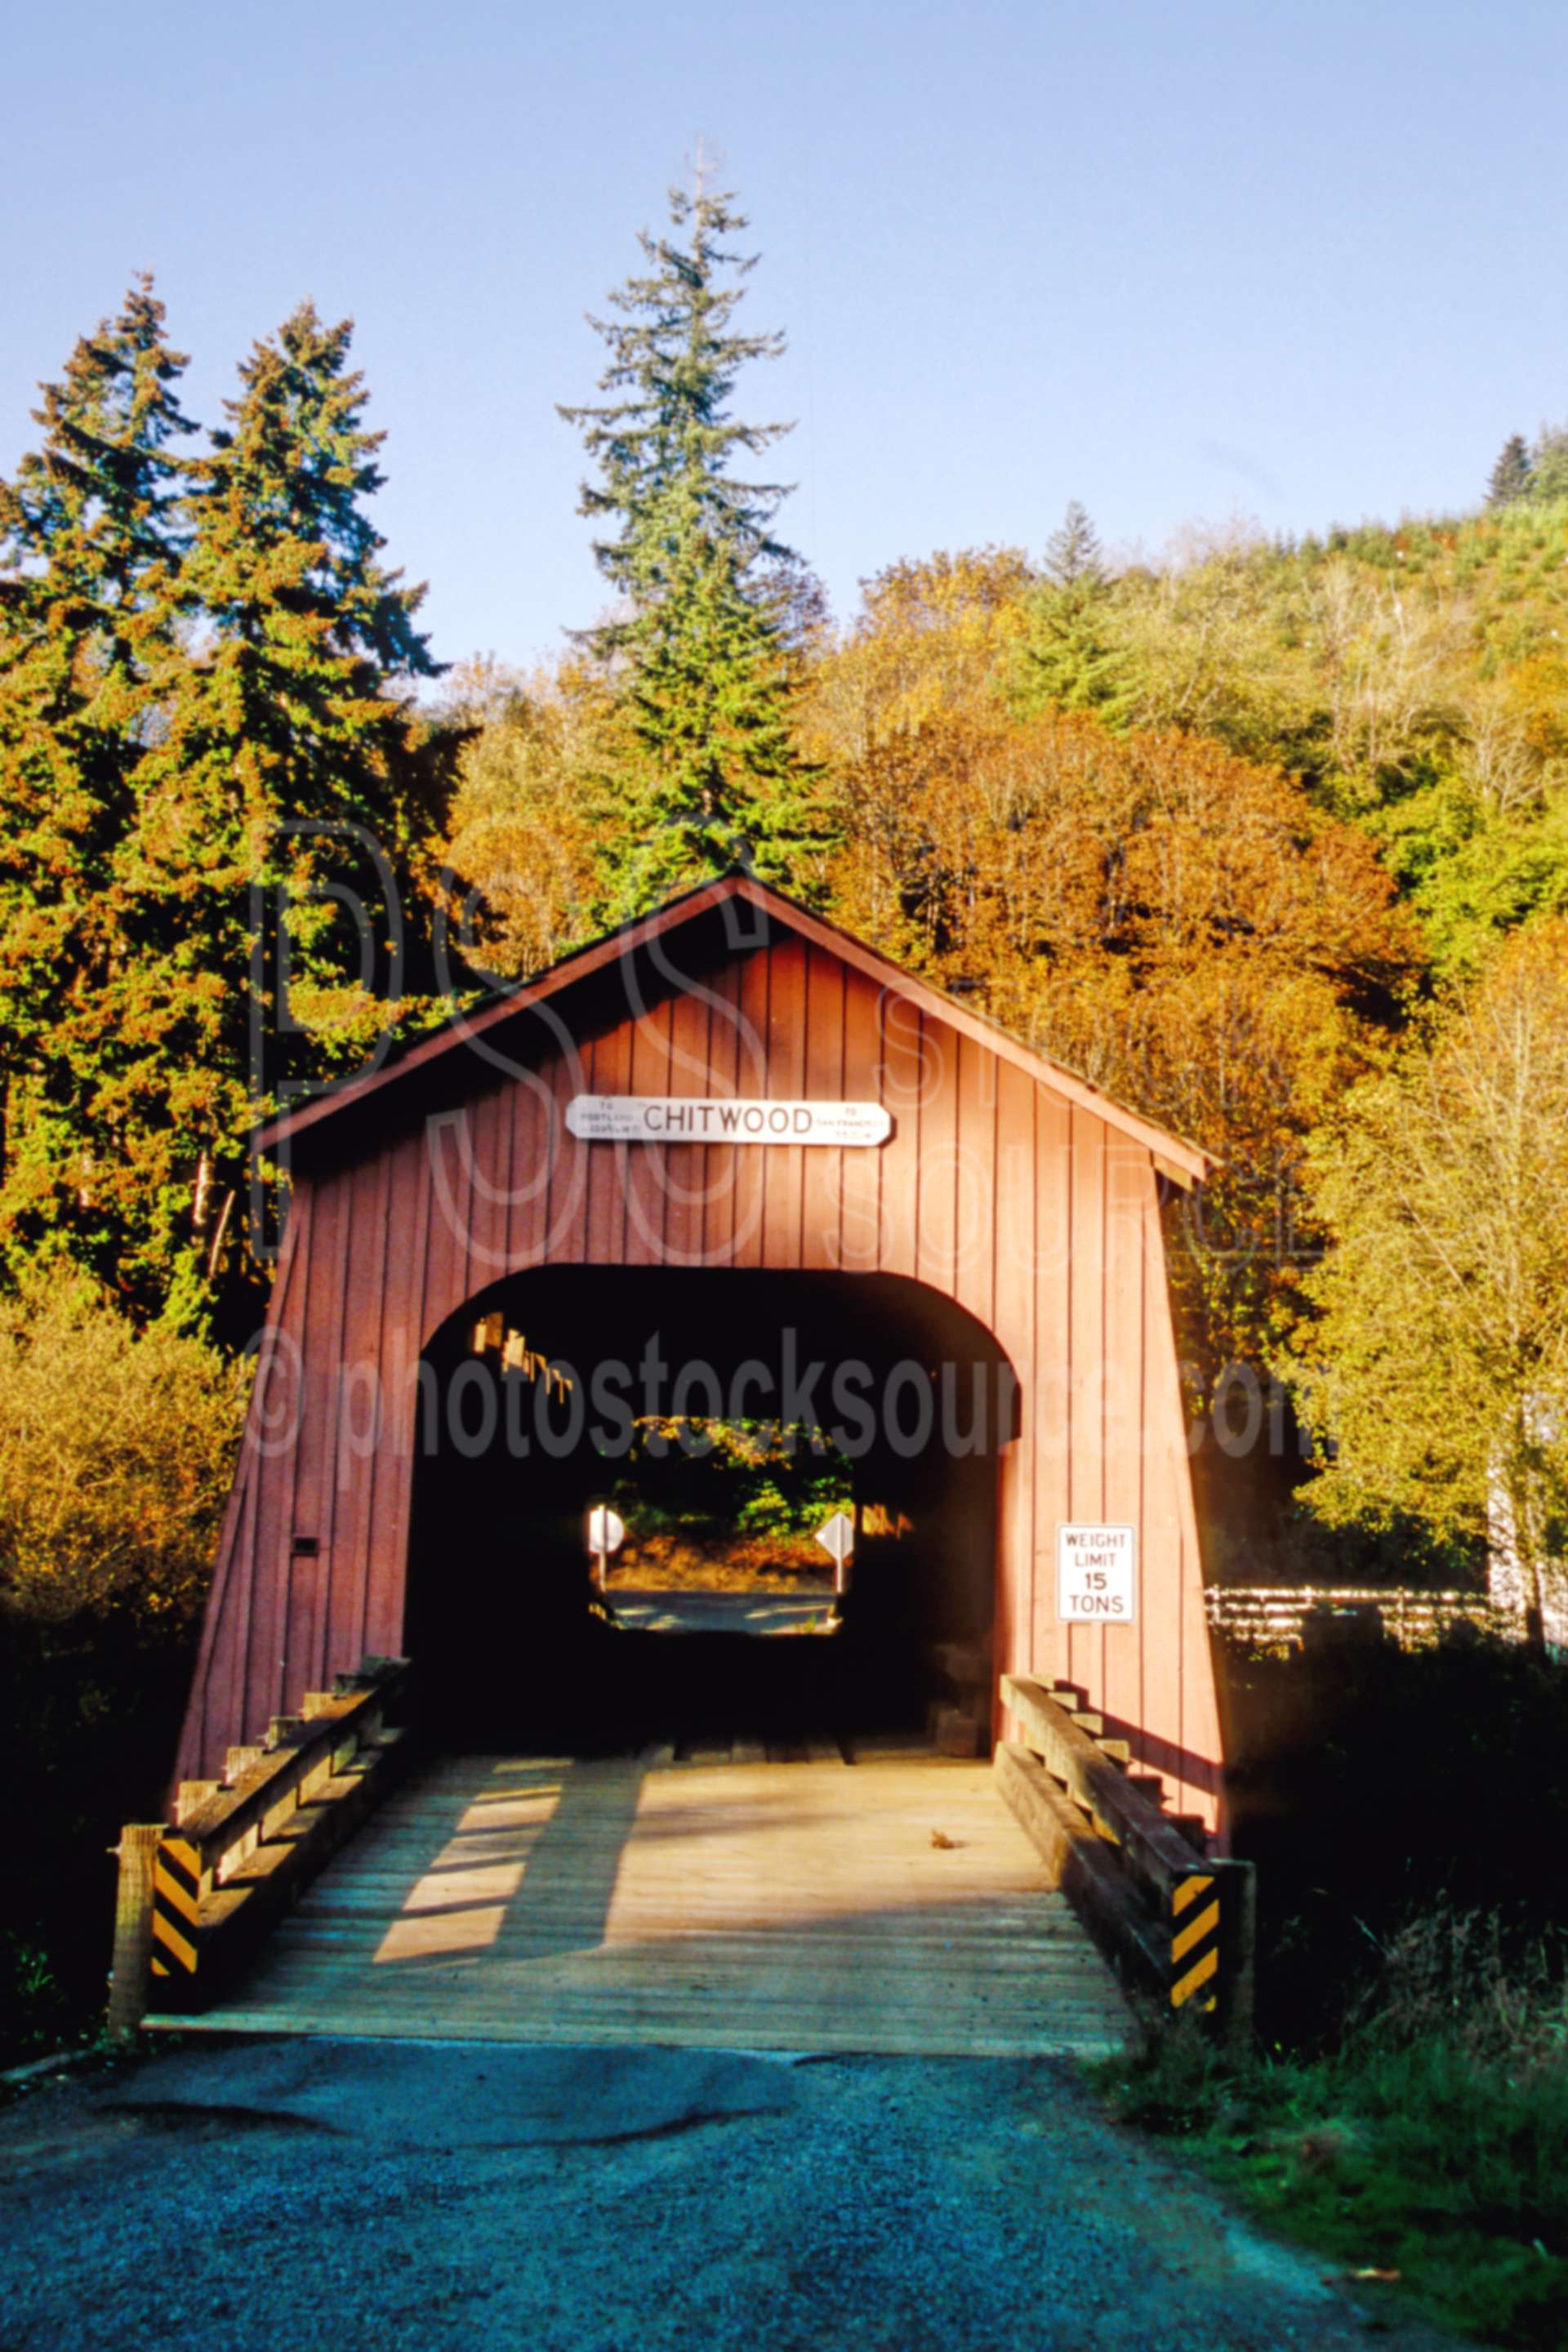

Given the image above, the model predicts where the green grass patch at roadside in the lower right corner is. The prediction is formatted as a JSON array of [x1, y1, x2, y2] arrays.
[[1094, 1910, 1568, 2352]]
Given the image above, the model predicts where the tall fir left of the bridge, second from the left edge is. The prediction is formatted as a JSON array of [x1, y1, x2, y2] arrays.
[[115, 304, 439, 1326]]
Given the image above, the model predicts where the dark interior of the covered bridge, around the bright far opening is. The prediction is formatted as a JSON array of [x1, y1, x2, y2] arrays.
[[404, 1265, 1018, 1753]]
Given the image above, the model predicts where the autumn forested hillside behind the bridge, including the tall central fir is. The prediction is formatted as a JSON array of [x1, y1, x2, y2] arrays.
[[444, 198, 1568, 1601]]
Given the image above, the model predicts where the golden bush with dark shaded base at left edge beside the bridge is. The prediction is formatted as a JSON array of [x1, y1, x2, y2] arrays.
[[0, 1275, 249, 2065]]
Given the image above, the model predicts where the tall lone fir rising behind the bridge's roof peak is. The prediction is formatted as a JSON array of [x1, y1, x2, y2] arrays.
[[559, 179, 821, 915]]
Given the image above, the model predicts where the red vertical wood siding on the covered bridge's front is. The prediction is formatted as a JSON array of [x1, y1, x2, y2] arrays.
[[179, 929, 1220, 1820]]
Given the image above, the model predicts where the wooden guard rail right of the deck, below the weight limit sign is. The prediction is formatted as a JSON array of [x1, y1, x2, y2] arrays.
[[995, 1675, 1258, 2039]]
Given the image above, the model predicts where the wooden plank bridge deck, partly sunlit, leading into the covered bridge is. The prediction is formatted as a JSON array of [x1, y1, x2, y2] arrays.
[[148, 1748, 1129, 2056]]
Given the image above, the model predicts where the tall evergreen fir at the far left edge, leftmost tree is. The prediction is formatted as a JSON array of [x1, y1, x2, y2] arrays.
[[0, 278, 193, 1298]]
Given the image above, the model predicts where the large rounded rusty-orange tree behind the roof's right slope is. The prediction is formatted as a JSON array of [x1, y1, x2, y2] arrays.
[[832, 686, 1415, 1381]]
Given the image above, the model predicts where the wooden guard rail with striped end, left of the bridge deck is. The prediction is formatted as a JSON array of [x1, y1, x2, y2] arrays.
[[108, 1658, 409, 2032]]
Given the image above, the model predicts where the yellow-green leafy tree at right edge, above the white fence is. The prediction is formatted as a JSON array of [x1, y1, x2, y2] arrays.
[[1293, 920, 1568, 1639]]
